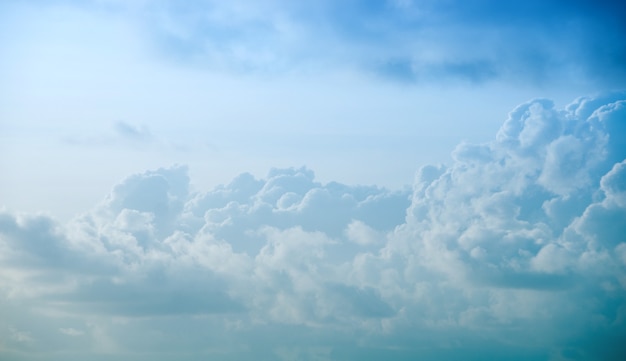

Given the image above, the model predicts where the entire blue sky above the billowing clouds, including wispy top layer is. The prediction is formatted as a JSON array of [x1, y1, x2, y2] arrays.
[[0, 1, 608, 217]]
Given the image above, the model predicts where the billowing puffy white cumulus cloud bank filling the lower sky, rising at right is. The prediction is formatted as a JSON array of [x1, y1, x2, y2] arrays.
[[0, 93, 626, 360]]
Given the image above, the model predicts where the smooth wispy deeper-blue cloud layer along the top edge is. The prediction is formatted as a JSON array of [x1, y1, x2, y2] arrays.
[[128, 0, 626, 85]]
